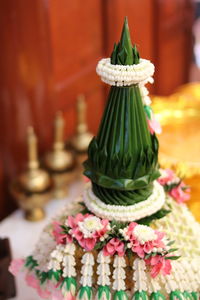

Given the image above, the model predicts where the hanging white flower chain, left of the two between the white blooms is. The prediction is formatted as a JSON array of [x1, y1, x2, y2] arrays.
[[97, 251, 110, 286]]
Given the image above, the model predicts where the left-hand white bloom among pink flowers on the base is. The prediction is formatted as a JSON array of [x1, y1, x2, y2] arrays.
[[78, 216, 103, 238]]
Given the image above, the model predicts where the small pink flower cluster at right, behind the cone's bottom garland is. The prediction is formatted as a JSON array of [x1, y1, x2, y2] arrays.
[[158, 169, 190, 203]]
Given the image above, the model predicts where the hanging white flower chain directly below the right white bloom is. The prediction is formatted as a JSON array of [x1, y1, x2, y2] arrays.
[[133, 258, 147, 292]]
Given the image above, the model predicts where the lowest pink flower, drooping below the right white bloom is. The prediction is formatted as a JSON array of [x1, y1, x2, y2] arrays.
[[145, 255, 172, 278]]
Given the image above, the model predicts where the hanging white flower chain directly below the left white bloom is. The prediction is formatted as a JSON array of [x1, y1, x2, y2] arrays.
[[80, 253, 94, 287]]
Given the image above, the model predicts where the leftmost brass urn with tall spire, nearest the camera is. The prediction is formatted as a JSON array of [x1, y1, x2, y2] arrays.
[[11, 127, 51, 221]]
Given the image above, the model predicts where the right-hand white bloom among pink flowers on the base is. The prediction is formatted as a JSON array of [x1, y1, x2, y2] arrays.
[[133, 225, 157, 244]]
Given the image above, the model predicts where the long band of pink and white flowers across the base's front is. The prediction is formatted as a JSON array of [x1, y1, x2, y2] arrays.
[[49, 213, 178, 276]]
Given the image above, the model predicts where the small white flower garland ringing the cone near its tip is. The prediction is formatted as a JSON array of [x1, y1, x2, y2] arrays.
[[96, 58, 155, 86]]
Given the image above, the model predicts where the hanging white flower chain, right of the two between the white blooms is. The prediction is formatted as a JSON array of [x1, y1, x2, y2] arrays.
[[112, 255, 126, 291]]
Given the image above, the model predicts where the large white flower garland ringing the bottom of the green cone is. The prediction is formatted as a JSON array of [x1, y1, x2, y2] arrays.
[[83, 181, 165, 222]]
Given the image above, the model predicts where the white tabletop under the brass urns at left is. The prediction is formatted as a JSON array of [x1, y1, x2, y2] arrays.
[[0, 181, 83, 300]]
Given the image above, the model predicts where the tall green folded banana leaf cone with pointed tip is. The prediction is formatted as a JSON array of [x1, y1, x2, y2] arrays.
[[84, 19, 160, 206]]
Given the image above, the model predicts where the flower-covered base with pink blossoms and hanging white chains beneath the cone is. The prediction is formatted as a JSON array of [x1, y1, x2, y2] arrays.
[[11, 170, 200, 300]]
